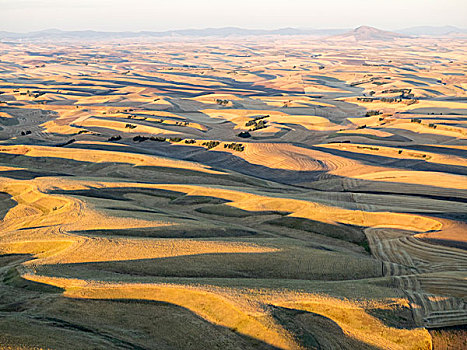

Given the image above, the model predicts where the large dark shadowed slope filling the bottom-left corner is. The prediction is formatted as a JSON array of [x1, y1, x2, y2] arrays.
[[0, 296, 278, 350]]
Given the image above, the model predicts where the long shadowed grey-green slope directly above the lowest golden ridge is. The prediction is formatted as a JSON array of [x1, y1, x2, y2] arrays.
[[34, 248, 381, 281]]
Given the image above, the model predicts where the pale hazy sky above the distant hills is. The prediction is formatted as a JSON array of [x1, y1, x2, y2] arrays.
[[0, 0, 467, 32]]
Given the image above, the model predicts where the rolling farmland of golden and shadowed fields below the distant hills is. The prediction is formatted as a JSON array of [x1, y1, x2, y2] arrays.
[[0, 32, 467, 350]]
